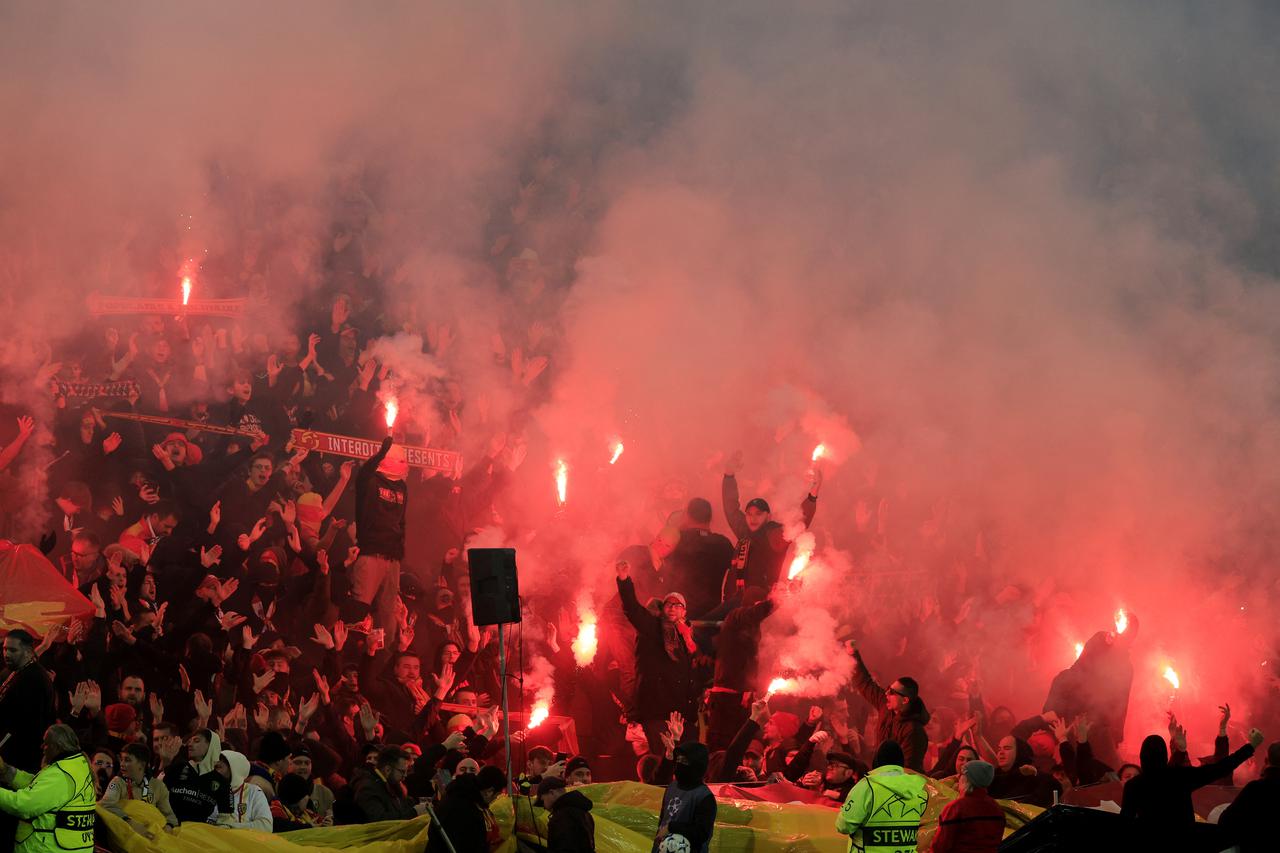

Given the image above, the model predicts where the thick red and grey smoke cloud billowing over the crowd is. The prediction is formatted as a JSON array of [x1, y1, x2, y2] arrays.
[[0, 1, 1280, 758]]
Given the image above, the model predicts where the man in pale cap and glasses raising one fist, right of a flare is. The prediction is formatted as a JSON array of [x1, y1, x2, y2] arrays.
[[617, 560, 698, 756]]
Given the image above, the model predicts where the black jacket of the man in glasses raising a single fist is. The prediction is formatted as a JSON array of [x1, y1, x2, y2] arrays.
[[618, 578, 695, 720]]
